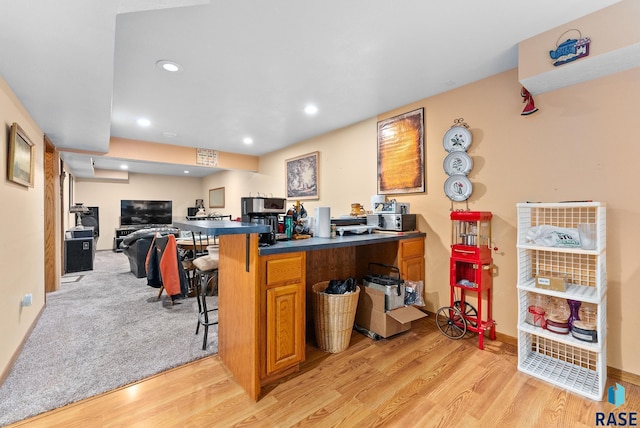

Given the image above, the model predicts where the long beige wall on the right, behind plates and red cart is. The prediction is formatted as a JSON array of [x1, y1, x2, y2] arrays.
[[219, 69, 640, 374]]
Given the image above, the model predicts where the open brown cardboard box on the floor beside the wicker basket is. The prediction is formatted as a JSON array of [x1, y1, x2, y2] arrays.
[[356, 285, 427, 338]]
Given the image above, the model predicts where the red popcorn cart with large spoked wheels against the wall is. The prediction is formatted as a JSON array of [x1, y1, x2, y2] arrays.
[[436, 211, 496, 349]]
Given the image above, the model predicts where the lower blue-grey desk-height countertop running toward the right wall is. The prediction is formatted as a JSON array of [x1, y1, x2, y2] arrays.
[[259, 232, 427, 256]]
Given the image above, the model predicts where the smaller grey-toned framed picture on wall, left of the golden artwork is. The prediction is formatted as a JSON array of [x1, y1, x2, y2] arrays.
[[284, 152, 320, 200]]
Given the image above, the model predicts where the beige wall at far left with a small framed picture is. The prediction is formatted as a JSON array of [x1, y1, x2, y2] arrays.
[[0, 77, 45, 377]]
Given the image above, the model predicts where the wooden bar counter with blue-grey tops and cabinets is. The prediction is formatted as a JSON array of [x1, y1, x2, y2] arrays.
[[173, 220, 426, 401]]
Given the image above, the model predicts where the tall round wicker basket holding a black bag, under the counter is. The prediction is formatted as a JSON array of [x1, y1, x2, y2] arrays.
[[311, 281, 360, 354]]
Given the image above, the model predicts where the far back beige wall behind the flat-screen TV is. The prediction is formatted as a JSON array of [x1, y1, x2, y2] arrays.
[[73, 174, 203, 251]]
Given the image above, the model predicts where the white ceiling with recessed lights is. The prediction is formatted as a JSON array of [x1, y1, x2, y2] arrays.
[[0, 0, 619, 177]]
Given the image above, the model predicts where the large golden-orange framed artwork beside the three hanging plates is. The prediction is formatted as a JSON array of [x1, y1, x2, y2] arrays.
[[378, 108, 425, 195]]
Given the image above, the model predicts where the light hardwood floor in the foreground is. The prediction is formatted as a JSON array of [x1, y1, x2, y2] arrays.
[[7, 317, 640, 428]]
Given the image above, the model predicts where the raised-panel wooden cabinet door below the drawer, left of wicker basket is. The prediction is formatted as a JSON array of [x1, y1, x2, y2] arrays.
[[266, 283, 305, 374]]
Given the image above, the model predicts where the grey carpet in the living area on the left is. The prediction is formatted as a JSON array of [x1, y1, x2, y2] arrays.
[[0, 251, 218, 425]]
